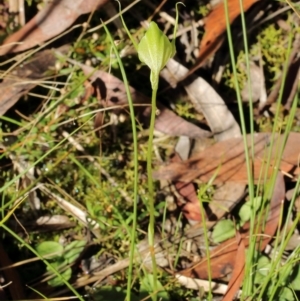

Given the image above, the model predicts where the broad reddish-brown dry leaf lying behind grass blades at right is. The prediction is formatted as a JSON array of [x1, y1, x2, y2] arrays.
[[153, 133, 300, 184]]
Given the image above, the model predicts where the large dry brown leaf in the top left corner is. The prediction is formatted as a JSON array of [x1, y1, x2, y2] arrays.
[[0, 0, 108, 55]]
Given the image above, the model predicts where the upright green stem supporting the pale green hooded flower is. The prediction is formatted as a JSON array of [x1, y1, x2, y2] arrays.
[[147, 85, 157, 300]]
